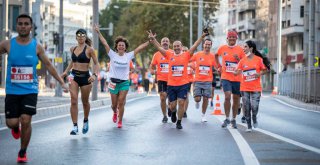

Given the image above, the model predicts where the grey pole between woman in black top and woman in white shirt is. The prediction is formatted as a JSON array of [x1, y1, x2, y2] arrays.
[[91, 0, 99, 101]]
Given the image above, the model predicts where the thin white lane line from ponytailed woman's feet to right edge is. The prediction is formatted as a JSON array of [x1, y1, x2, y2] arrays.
[[239, 123, 320, 154]]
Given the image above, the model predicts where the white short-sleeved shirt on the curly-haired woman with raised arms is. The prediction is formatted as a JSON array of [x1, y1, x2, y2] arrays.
[[108, 49, 134, 80]]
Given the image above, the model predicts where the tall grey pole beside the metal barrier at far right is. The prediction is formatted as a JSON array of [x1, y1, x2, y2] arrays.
[[306, 0, 316, 102]]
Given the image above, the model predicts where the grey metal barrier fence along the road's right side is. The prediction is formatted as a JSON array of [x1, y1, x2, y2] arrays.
[[278, 68, 320, 104]]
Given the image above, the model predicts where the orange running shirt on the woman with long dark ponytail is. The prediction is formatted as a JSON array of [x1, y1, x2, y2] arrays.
[[237, 55, 266, 92]]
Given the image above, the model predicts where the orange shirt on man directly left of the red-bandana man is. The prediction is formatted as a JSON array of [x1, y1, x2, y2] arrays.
[[190, 51, 216, 82]]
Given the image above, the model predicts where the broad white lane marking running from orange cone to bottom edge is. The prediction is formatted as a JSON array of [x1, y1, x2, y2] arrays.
[[214, 116, 260, 165]]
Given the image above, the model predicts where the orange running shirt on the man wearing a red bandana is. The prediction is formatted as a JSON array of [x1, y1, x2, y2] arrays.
[[217, 45, 245, 82]]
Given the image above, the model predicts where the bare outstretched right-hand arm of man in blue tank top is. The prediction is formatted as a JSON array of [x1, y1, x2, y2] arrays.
[[37, 44, 69, 92]]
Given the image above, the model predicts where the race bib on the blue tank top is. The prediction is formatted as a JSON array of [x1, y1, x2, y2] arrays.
[[11, 66, 33, 83]]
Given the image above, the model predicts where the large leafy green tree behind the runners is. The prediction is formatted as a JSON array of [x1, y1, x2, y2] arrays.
[[100, 0, 218, 67]]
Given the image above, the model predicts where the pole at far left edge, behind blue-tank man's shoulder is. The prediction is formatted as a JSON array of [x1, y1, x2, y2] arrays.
[[0, 0, 8, 88]]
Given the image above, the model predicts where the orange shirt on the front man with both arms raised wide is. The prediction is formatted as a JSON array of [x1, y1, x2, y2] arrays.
[[166, 50, 190, 86]]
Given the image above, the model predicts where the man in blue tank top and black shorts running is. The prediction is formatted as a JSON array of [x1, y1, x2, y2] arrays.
[[0, 14, 69, 163]]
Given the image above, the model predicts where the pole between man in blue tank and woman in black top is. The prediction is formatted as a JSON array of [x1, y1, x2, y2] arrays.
[[55, 0, 63, 97]]
